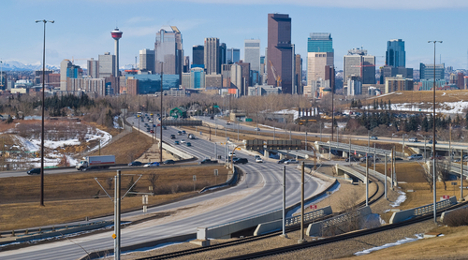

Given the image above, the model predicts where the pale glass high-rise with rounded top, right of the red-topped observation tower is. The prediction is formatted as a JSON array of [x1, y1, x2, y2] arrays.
[[154, 26, 184, 77]]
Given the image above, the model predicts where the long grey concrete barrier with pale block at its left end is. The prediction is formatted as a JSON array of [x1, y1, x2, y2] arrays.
[[197, 210, 283, 240]]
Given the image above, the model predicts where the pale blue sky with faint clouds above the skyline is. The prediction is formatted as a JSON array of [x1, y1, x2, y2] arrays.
[[0, 0, 468, 70]]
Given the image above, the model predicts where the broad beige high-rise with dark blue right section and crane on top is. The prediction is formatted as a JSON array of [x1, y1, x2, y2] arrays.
[[343, 48, 375, 84]]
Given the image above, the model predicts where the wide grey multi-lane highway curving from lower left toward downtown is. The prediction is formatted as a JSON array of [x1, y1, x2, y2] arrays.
[[0, 116, 323, 259]]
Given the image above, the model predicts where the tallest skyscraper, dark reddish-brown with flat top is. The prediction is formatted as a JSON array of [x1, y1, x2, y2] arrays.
[[267, 14, 293, 94]]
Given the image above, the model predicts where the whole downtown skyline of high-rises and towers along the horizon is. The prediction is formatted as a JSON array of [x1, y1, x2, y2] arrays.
[[0, 13, 468, 98]]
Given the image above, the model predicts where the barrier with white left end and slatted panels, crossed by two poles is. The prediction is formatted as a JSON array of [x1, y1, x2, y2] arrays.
[[254, 206, 332, 236]]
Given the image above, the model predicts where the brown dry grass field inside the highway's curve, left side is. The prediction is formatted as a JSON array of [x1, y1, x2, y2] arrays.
[[0, 166, 227, 230]]
